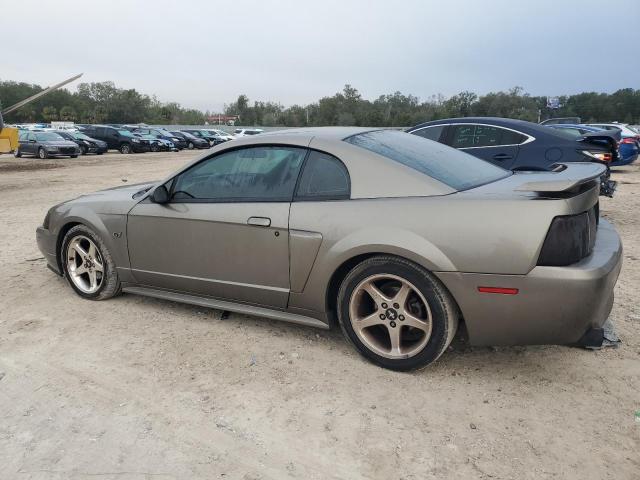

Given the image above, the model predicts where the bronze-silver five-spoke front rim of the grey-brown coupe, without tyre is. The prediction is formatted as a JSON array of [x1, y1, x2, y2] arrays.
[[66, 235, 104, 293]]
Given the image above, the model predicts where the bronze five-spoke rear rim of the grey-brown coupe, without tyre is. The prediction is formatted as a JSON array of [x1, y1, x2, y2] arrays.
[[349, 274, 433, 359]]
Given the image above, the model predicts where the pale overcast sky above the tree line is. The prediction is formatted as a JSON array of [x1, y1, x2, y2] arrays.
[[5, 0, 640, 111]]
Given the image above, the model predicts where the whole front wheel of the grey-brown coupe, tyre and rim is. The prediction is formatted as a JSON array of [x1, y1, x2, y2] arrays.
[[59, 225, 120, 300]]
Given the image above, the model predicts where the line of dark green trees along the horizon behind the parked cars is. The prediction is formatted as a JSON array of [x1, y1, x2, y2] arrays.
[[0, 81, 640, 127]]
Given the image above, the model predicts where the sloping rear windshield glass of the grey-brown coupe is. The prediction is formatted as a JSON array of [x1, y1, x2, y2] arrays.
[[345, 130, 511, 190]]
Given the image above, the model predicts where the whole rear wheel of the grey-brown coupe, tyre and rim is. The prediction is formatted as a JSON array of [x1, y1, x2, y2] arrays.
[[337, 256, 458, 371]]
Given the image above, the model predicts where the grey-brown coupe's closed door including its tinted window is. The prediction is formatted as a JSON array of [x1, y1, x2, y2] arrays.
[[127, 146, 306, 308]]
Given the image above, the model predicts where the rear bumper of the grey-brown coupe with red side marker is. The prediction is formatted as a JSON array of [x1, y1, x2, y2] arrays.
[[436, 219, 622, 345]]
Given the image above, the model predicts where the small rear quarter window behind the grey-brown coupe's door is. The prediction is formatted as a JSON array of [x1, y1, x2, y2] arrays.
[[295, 150, 351, 200]]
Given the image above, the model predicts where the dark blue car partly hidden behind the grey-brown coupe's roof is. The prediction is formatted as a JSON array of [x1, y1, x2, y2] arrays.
[[407, 117, 619, 196]]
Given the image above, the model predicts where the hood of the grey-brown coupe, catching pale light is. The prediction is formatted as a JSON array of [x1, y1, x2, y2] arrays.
[[66, 181, 158, 215]]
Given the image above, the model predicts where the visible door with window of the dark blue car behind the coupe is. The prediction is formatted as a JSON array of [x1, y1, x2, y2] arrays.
[[447, 123, 527, 169]]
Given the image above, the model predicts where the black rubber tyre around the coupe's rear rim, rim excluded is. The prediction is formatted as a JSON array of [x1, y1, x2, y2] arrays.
[[337, 255, 459, 371]]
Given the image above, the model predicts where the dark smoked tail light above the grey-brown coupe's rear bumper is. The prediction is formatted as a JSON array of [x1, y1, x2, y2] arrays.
[[538, 205, 598, 267]]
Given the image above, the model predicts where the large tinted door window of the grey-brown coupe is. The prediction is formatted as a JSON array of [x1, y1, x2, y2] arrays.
[[172, 146, 307, 202]]
